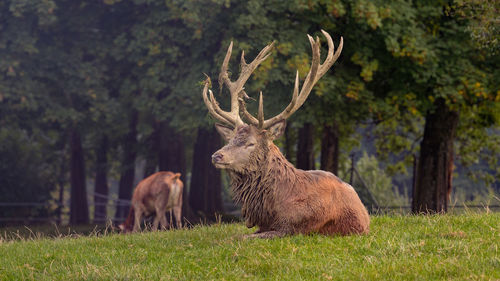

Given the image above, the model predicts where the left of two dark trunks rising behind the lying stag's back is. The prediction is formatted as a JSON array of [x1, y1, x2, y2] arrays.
[[297, 123, 314, 170]]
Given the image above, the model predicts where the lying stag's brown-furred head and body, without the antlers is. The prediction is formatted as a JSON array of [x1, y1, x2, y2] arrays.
[[212, 121, 370, 238]]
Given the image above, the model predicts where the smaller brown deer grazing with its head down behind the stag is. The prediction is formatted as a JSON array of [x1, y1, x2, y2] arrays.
[[119, 172, 184, 232]]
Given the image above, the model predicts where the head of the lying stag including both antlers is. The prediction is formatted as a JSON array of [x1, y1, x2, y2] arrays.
[[203, 30, 343, 173]]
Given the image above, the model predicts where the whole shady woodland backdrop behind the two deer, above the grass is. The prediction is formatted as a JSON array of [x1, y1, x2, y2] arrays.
[[0, 0, 500, 226]]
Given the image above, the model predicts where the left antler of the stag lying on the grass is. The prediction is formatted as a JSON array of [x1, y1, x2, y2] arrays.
[[203, 42, 274, 127]]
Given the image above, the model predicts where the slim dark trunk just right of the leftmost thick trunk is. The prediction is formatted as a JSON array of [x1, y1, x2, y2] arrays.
[[94, 136, 109, 224]]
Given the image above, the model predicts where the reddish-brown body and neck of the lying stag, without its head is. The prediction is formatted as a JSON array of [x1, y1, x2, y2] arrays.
[[230, 147, 370, 236]]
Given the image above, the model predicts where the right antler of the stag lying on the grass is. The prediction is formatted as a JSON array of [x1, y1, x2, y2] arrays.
[[240, 30, 344, 129]]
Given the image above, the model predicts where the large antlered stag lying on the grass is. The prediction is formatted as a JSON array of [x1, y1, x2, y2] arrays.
[[203, 30, 370, 238]]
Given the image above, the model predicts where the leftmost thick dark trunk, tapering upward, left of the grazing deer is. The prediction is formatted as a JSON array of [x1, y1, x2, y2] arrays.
[[69, 128, 89, 225]]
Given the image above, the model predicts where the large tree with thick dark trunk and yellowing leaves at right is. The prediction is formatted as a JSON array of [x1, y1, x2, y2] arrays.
[[306, 0, 495, 213]]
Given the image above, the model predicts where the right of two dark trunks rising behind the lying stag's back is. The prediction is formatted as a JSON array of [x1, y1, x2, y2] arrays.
[[321, 123, 340, 175]]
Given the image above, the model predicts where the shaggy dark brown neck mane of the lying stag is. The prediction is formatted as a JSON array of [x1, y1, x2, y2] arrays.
[[229, 144, 297, 228]]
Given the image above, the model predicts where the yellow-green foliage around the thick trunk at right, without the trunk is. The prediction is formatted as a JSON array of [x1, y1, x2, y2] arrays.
[[319, 1, 500, 186]]
